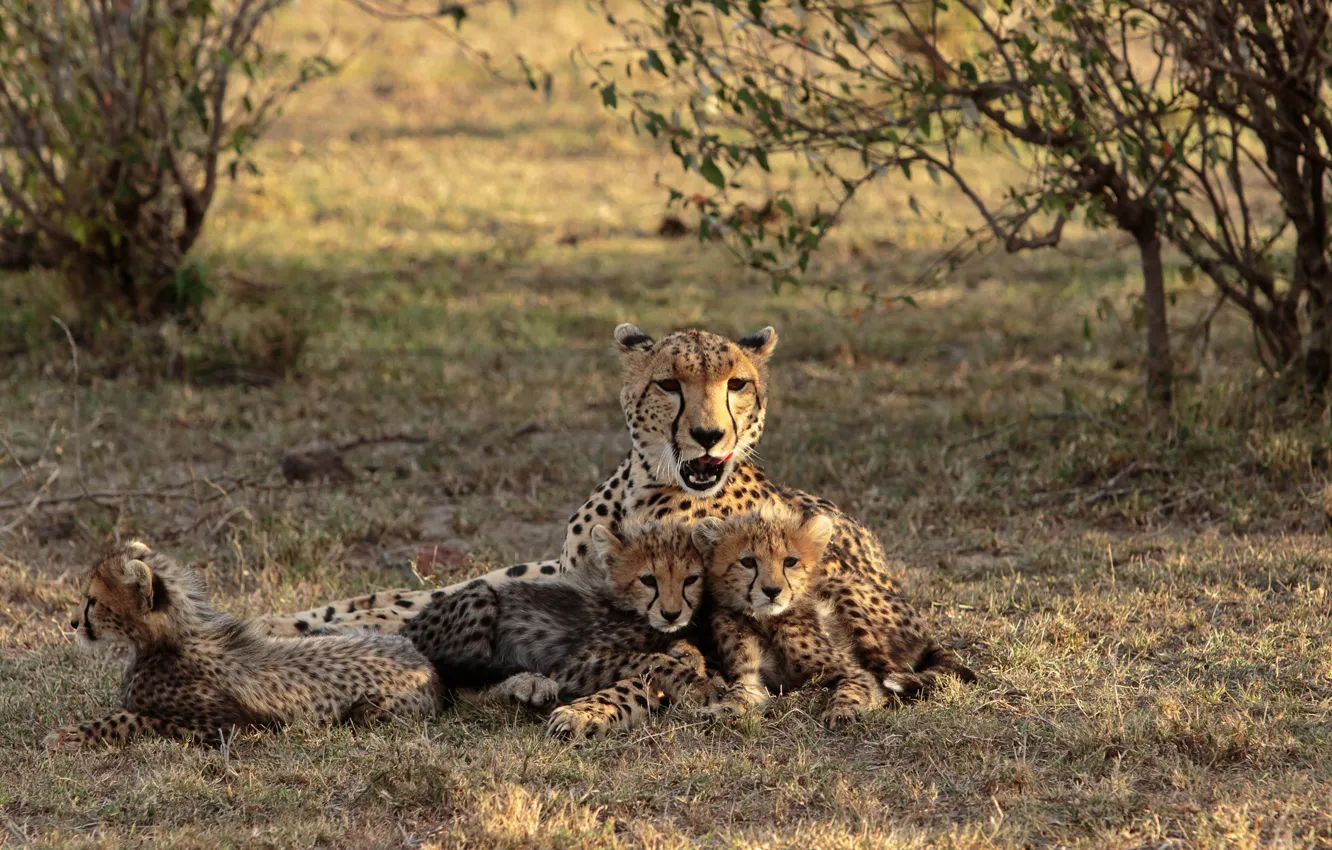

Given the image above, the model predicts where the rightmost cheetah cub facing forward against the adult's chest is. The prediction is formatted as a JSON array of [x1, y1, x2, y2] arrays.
[[694, 505, 882, 727]]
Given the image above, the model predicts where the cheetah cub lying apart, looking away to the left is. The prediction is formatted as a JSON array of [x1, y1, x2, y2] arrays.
[[45, 541, 441, 749]]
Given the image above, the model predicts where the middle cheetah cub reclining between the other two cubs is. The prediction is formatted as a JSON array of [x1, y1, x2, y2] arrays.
[[401, 522, 725, 737]]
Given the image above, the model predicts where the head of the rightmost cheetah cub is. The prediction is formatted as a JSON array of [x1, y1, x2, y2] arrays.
[[694, 506, 833, 617]]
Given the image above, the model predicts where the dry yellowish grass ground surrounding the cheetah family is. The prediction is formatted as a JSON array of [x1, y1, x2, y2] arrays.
[[0, 0, 1332, 849]]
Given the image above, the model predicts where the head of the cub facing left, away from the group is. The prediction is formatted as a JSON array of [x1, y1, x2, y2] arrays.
[[69, 540, 208, 647]]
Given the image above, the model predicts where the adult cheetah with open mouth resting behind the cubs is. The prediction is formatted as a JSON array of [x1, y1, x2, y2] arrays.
[[259, 324, 975, 698]]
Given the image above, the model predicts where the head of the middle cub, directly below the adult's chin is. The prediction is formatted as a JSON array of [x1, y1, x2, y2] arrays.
[[591, 522, 705, 632]]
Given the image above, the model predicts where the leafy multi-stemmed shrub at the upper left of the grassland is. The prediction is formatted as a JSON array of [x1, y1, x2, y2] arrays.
[[0, 0, 332, 333]]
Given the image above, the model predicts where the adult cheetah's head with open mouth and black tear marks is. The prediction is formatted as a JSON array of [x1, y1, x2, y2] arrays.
[[615, 324, 777, 497]]
